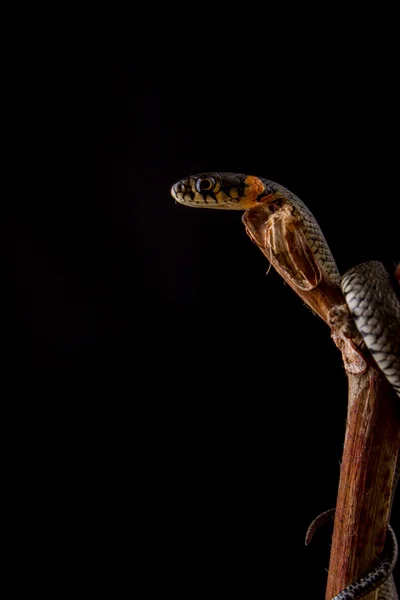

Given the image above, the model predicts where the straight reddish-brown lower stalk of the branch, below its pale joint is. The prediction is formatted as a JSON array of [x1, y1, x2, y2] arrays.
[[325, 365, 400, 600]]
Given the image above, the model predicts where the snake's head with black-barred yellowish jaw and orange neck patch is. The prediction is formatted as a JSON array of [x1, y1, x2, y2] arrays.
[[171, 172, 269, 210]]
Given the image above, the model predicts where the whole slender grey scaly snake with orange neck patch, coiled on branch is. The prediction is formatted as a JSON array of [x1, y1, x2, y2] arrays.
[[171, 172, 400, 600]]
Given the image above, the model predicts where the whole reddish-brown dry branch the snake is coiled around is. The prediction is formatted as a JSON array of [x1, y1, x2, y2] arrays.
[[243, 205, 400, 600]]
